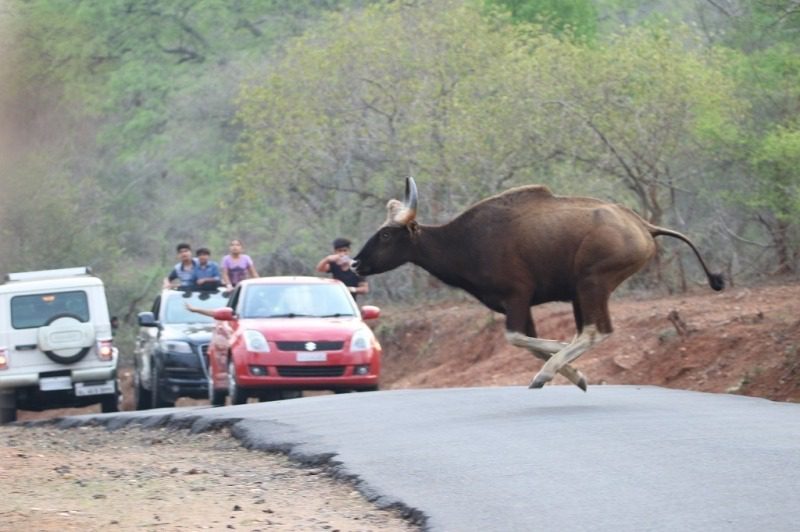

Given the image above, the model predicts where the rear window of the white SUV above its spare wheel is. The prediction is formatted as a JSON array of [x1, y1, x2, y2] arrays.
[[11, 290, 89, 329]]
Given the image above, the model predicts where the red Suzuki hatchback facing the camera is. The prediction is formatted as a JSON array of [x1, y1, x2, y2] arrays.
[[208, 277, 382, 406]]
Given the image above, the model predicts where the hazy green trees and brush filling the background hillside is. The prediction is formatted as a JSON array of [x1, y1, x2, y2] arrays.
[[0, 0, 800, 342]]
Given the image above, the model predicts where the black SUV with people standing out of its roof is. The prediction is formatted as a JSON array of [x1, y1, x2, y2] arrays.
[[134, 289, 228, 410]]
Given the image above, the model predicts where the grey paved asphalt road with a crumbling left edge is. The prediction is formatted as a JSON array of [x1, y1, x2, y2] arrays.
[[48, 386, 800, 532]]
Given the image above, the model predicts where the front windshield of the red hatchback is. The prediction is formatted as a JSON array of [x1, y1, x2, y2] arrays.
[[241, 283, 358, 318]]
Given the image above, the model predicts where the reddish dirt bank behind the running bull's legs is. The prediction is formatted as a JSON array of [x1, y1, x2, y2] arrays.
[[377, 281, 800, 402]]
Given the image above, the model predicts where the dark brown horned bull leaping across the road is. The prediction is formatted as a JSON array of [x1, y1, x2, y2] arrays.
[[353, 178, 724, 390]]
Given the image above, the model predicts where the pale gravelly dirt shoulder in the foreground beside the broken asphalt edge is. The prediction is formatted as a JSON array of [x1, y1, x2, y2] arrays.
[[0, 426, 419, 532]]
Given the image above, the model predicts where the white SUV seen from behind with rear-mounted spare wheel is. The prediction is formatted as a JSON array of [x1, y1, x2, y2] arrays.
[[0, 267, 119, 423]]
